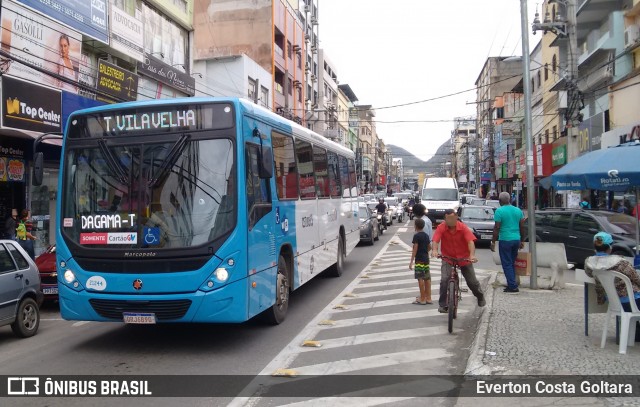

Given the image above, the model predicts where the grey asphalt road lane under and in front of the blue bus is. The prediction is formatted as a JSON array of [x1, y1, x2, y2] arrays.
[[0, 222, 495, 406]]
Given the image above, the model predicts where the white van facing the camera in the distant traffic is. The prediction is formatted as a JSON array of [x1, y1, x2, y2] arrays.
[[420, 177, 460, 226]]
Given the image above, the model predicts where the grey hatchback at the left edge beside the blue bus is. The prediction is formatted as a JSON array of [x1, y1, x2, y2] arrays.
[[0, 240, 43, 338]]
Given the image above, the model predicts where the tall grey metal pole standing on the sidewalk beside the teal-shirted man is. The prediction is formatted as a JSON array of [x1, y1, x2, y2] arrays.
[[520, 0, 538, 290]]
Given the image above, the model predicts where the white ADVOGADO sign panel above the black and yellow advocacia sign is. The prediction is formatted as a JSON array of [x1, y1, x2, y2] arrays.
[[111, 7, 144, 62]]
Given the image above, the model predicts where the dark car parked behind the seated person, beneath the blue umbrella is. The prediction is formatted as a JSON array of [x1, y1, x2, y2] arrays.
[[525, 208, 636, 267]]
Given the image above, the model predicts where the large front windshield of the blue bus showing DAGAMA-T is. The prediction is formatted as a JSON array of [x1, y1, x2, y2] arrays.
[[61, 139, 237, 250]]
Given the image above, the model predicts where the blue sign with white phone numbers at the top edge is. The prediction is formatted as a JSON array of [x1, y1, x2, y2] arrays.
[[17, 0, 109, 44]]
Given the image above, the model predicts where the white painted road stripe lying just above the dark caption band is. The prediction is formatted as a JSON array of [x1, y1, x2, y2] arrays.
[[292, 348, 451, 375]]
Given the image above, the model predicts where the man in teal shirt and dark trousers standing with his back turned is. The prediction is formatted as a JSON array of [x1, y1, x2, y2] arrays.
[[491, 192, 524, 293]]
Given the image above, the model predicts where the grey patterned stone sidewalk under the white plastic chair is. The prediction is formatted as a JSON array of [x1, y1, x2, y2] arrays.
[[456, 266, 640, 407]]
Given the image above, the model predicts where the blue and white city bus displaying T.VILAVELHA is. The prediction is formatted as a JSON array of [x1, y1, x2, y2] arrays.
[[34, 98, 360, 324]]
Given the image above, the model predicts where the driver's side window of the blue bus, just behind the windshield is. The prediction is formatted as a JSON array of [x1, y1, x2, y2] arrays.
[[245, 143, 271, 229]]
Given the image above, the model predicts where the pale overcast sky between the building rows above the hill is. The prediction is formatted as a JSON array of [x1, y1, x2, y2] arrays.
[[318, 0, 542, 160]]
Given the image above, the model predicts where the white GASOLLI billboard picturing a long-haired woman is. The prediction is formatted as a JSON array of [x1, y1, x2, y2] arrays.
[[1, 0, 82, 93]]
